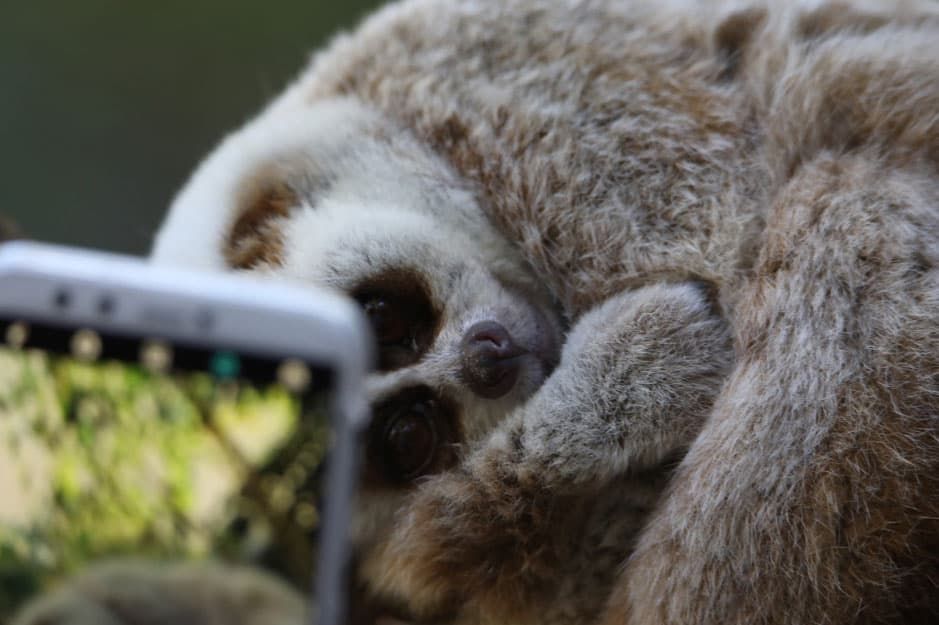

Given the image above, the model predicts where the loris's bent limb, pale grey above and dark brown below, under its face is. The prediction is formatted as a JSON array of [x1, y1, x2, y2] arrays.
[[362, 284, 733, 621]]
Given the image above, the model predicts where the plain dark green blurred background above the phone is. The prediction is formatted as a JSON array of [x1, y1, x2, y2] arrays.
[[0, 0, 381, 254]]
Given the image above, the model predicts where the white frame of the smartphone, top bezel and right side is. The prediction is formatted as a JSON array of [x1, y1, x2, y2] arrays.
[[0, 241, 373, 625]]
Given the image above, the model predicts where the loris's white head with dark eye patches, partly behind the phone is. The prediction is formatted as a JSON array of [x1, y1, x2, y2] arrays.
[[153, 97, 560, 616]]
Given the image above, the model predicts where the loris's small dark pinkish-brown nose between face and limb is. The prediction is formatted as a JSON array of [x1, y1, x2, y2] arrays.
[[462, 321, 525, 399]]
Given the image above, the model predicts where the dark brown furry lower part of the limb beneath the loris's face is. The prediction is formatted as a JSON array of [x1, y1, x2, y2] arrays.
[[365, 436, 565, 622]]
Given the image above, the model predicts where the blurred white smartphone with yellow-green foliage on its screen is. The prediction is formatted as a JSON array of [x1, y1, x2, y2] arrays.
[[0, 242, 371, 625]]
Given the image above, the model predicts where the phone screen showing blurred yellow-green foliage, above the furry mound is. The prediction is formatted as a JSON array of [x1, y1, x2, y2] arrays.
[[0, 319, 334, 622]]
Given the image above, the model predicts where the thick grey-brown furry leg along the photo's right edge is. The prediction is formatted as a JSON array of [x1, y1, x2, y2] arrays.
[[606, 153, 939, 623]]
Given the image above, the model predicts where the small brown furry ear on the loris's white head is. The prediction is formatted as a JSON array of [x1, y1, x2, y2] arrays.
[[222, 169, 298, 269]]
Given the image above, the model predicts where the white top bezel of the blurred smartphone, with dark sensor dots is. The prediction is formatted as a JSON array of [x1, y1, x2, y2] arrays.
[[0, 241, 372, 416]]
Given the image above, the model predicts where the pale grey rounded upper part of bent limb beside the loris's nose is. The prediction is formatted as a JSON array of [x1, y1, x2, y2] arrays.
[[521, 283, 733, 489]]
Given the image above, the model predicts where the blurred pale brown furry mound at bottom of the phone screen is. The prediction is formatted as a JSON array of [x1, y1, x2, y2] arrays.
[[13, 561, 307, 625]]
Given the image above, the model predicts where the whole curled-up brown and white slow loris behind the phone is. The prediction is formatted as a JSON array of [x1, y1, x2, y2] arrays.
[[12, 0, 939, 625]]
